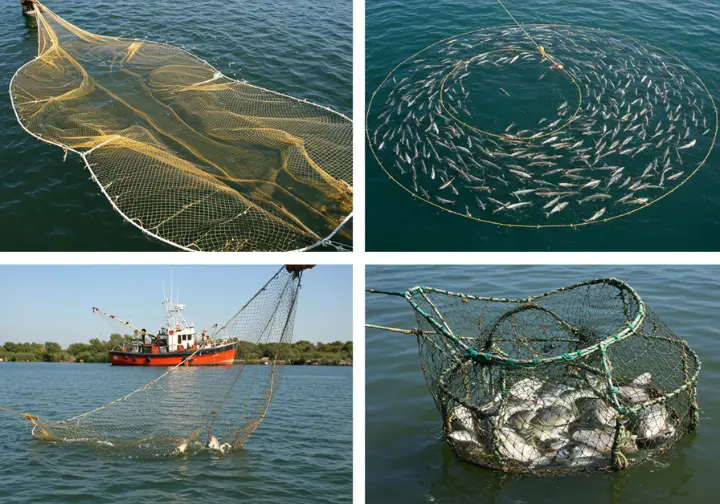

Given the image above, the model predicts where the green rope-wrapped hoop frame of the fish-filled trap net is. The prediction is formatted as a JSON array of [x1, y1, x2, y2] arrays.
[[366, 278, 702, 476]]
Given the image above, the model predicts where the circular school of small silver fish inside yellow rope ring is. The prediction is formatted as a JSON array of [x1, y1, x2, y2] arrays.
[[367, 25, 717, 226]]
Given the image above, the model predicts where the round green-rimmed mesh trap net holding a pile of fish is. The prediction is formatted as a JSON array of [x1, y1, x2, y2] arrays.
[[371, 278, 700, 474]]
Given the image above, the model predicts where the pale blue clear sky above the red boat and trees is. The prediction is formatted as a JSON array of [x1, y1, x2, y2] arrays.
[[0, 265, 352, 348]]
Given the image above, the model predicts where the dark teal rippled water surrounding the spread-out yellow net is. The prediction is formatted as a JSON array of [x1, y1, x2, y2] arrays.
[[0, 0, 352, 251]]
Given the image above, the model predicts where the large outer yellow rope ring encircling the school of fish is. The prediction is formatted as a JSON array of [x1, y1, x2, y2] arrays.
[[365, 23, 720, 229]]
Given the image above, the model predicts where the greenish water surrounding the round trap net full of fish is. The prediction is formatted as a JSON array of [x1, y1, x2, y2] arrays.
[[365, 266, 720, 504]]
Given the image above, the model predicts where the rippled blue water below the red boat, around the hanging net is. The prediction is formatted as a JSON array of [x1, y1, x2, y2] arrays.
[[0, 363, 352, 504]]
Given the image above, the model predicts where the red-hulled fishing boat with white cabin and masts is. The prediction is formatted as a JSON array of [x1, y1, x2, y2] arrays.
[[98, 299, 237, 366]]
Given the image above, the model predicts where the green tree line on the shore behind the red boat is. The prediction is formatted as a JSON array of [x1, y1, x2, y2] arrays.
[[0, 333, 353, 364]]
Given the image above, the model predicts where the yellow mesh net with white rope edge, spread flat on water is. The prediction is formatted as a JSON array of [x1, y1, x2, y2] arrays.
[[10, 1, 353, 251]]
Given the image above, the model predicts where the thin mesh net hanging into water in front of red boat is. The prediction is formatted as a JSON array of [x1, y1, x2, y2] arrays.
[[0, 267, 302, 458]]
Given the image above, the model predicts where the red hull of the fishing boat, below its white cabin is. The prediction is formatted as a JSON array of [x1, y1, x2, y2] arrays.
[[110, 343, 237, 366]]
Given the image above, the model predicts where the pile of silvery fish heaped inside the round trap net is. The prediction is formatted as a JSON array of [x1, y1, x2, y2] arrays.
[[447, 373, 679, 470]]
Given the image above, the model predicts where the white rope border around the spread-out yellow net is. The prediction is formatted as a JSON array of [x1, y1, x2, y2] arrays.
[[8, 0, 354, 252]]
